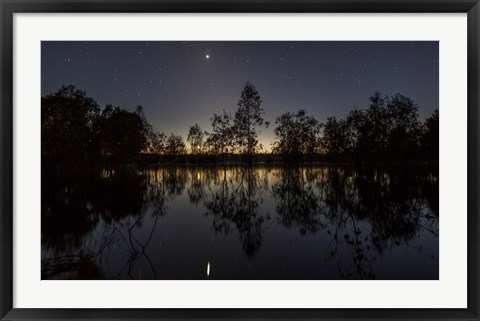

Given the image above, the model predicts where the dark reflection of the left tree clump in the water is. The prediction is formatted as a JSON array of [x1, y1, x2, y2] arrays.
[[42, 166, 172, 278]]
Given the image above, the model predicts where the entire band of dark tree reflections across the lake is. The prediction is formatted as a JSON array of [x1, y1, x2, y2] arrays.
[[42, 165, 438, 279]]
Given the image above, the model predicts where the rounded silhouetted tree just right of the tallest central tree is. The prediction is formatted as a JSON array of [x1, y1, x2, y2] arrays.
[[273, 109, 320, 160]]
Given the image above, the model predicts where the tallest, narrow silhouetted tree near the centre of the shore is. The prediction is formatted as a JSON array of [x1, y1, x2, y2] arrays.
[[234, 81, 264, 160]]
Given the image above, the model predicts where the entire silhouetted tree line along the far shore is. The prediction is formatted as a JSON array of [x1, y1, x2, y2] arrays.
[[41, 82, 439, 166]]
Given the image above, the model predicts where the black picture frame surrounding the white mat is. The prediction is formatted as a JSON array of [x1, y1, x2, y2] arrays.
[[0, 0, 480, 320]]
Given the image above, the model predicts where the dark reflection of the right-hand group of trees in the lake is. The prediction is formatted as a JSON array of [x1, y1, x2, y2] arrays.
[[271, 167, 438, 279]]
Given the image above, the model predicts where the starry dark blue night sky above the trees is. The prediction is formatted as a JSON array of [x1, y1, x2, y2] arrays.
[[41, 41, 439, 150]]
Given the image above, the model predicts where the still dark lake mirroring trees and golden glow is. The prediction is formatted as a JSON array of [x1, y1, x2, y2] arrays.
[[41, 165, 439, 280]]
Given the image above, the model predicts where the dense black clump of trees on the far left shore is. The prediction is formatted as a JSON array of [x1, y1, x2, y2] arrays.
[[41, 85, 152, 165]]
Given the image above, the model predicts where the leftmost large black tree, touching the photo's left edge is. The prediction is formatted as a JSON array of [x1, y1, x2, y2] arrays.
[[41, 85, 100, 163]]
